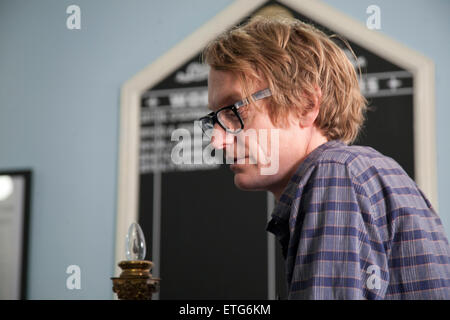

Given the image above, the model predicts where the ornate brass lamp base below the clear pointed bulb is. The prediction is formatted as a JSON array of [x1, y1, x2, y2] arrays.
[[111, 260, 160, 300]]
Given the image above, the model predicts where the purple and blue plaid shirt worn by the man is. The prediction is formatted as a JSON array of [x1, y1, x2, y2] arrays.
[[267, 140, 450, 299]]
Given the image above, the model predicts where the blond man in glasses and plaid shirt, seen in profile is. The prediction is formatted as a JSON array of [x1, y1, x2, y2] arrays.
[[201, 18, 450, 299]]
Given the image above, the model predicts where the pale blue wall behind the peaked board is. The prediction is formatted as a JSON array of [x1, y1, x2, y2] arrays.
[[0, 0, 450, 299]]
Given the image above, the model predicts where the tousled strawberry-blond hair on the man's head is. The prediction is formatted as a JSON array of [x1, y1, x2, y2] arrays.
[[203, 17, 367, 143]]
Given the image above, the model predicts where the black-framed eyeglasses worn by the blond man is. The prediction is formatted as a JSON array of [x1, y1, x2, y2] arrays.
[[198, 88, 272, 138]]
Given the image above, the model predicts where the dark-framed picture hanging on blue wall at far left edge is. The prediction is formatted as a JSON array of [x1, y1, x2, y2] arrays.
[[0, 170, 32, 300]]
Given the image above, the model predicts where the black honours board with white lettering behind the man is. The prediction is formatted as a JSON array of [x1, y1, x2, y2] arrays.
[[138, 1, 414, 299]]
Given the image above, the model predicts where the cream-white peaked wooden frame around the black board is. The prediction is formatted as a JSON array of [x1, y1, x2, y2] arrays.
[[115, 0, 438, 299]]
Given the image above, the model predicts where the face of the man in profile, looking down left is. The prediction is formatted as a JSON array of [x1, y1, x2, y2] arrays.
[[208, 68, 316, 195]]
